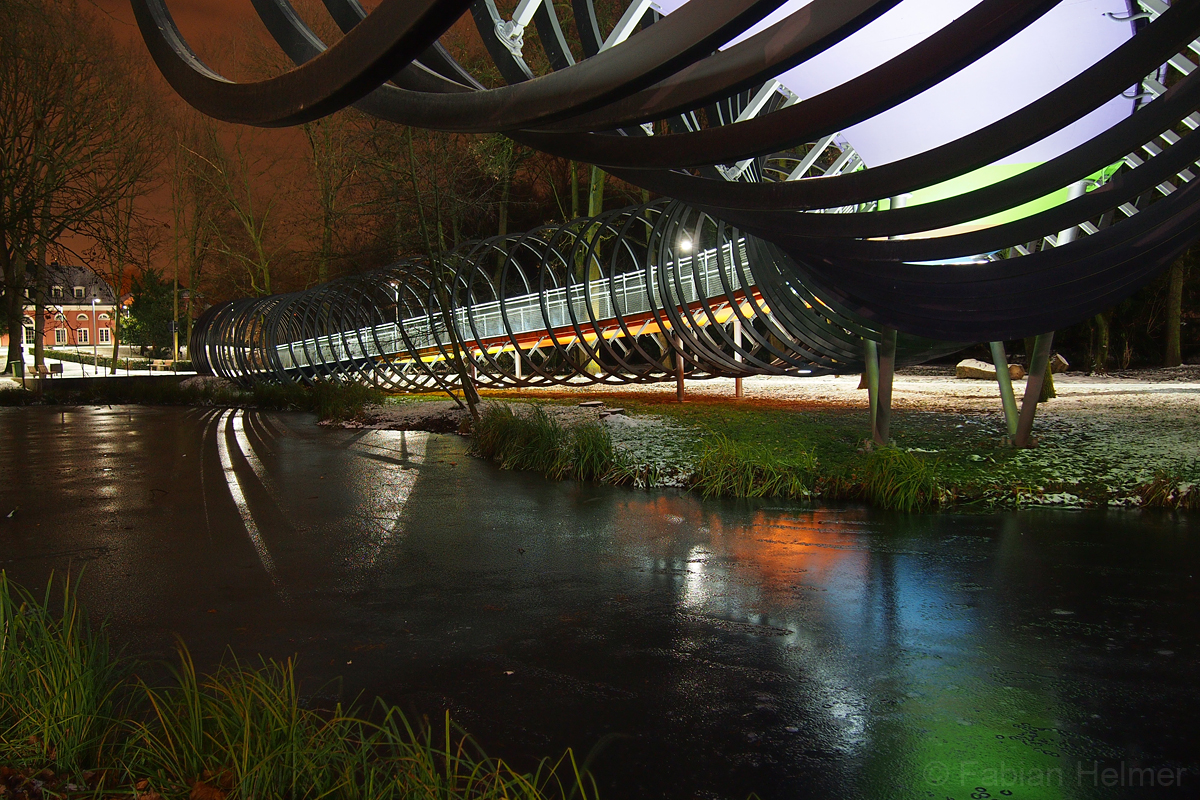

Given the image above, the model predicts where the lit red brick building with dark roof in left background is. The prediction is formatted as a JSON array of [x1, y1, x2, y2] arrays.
[[0, 264, 116, 353]]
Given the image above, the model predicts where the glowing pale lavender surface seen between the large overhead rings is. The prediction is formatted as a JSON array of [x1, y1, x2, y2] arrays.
[[658, 0, 1133, 167]]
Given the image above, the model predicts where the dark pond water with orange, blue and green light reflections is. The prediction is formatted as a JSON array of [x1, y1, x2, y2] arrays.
[[0, 408, 1200, 800]]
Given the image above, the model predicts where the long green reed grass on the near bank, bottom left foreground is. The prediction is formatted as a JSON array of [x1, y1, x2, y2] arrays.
[[0, 572, 596, 800]]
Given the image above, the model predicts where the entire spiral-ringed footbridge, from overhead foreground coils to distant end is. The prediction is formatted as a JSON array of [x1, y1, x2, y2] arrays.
[[132, 0, 1200, 407]]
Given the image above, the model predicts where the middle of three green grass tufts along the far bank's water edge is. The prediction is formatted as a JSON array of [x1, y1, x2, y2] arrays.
[[691, 434, 817, 500]]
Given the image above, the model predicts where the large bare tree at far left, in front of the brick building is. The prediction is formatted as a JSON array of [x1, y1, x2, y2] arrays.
[[0, 0, 159, 365]]
